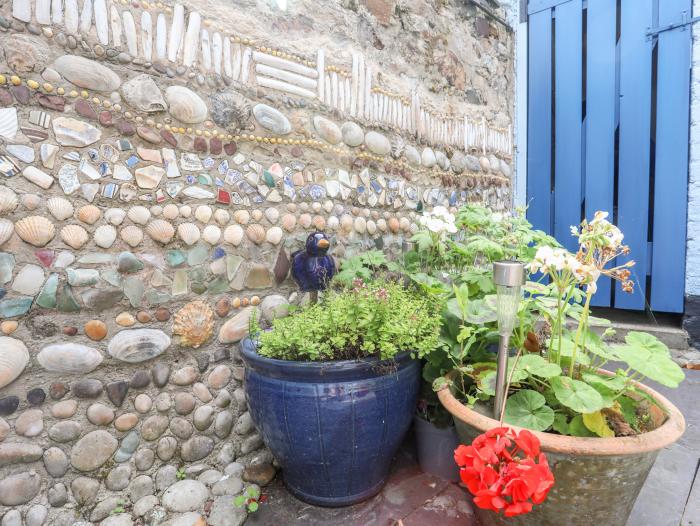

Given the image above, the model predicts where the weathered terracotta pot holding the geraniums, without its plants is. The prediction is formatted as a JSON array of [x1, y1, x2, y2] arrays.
[[438, 378, 685, 526]]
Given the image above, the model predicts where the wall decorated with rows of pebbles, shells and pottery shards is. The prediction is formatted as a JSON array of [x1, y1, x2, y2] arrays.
[[0, 0, 513, 526]]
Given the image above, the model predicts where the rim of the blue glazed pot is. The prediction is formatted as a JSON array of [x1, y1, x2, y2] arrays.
[[241, 338, 413, 382]]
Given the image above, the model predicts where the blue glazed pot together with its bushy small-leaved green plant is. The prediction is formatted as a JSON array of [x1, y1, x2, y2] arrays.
[[241, 280, 440, 506]]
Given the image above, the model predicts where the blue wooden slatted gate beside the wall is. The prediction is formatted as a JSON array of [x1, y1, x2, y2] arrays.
[[527, 0, 691, 312]]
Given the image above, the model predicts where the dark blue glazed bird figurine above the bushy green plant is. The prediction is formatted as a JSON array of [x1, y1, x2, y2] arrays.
[[292, 232, 336, 292]]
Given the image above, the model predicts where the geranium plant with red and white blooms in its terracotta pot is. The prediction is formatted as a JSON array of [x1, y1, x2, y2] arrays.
[[435, 213, 685, 526]]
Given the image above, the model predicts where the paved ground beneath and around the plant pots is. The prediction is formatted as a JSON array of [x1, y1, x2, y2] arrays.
[[246, 370, 700, 526]]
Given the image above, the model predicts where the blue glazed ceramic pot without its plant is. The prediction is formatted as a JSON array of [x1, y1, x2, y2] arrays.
[[241, 339, 420, 506]]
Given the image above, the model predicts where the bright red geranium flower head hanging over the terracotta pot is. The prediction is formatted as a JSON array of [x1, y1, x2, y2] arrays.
[[455, 427, 554, 517]]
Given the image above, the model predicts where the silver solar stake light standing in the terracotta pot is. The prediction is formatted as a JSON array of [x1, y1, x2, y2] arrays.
[[493, 261, 525, 420]]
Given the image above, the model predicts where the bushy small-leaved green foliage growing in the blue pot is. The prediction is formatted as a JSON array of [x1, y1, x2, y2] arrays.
[[258, 281, 440, 361]]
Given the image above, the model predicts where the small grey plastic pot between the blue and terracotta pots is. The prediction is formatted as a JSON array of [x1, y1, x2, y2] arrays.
[[413, 416, 459, 482]]
